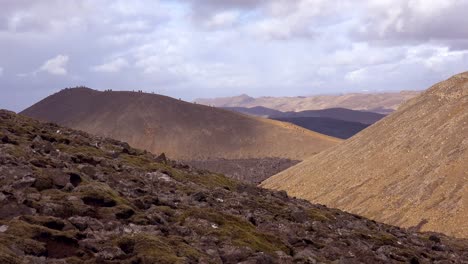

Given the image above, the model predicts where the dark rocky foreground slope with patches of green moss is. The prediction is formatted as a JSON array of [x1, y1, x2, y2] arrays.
[[0, 111, 468, 263]]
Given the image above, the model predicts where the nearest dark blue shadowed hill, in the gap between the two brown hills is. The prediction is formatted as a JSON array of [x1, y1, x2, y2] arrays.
[[272, 117, 369, 139]]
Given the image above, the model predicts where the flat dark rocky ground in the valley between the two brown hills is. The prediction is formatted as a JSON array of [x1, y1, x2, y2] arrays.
[[184, 158, 299, 184]]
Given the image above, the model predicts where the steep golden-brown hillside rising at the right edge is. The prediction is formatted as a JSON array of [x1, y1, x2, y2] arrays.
[[262, 73, 468, 237]]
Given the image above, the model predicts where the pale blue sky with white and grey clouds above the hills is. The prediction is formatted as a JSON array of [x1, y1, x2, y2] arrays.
[[0, 0, 468, 111]]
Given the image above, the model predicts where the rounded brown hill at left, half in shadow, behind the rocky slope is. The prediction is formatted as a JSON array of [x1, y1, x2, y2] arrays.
[[21, 88, 340, 160]]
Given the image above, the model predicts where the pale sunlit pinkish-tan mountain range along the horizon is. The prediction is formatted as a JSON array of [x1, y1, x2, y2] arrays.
[[195, 91, 420, 114]]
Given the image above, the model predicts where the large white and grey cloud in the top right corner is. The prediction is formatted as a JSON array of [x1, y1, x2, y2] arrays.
[[353, 0, 468, 45]]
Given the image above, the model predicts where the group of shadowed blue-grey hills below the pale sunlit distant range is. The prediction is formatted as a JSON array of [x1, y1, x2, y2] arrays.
[[223, 106, 385, 139]]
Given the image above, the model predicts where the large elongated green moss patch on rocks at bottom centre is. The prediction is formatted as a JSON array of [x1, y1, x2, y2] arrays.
[[179, 208, 288, 253]]
